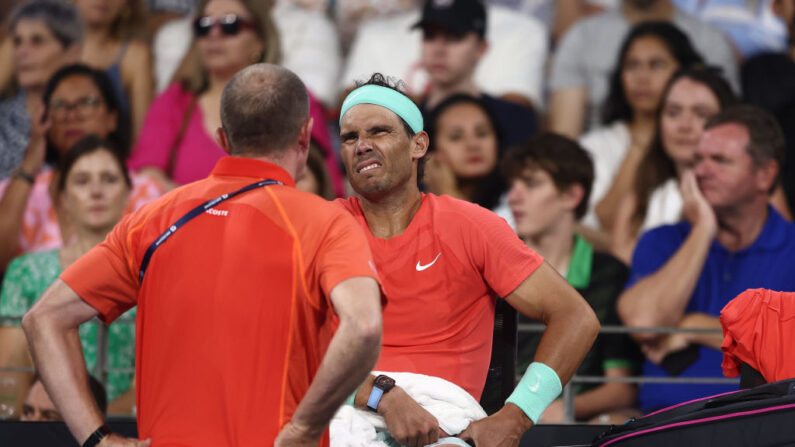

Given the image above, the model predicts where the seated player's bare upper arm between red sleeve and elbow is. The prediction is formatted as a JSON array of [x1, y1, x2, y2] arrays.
[[505, 262, 584, 323]]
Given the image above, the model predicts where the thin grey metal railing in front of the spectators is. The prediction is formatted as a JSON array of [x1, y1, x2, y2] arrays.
[[0, 316, 739, 423]]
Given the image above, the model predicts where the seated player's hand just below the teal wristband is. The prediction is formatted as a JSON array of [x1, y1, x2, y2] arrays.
[[458, 403, 533, 447]]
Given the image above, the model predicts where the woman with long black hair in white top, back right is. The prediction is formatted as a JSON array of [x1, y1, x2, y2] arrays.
[[580, 22, 702, 240]]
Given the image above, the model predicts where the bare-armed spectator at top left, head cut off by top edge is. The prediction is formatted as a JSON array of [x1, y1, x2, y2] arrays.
[[75, 0, 154, 139]]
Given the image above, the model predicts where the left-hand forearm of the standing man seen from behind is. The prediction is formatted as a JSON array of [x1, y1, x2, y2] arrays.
[[22, 307, 103, 444]]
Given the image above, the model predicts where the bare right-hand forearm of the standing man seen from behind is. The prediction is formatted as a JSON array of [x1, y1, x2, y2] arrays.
[[292, 316, 381, 434]]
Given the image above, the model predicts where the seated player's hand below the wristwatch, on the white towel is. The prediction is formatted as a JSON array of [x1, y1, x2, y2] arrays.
[[378, 386, 447, 447]]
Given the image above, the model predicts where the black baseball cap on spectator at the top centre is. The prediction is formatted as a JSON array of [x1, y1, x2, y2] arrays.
[[412, 0, 486, 38]]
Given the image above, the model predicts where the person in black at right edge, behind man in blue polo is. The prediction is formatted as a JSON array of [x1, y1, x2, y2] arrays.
[[741, 52, 795, 220]]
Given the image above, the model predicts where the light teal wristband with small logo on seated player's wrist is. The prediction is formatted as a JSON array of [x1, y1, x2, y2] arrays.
[[505, 362, 563, 424]]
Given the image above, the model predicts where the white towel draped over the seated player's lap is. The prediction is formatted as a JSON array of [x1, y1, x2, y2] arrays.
[[330, 371, 486, 447]]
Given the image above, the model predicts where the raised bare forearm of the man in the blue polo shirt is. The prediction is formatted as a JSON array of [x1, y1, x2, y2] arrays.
[[618, 225, 712, 341]]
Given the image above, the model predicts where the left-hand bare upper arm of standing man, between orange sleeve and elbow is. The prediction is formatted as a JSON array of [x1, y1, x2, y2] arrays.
[[28, 278, 99, 328]]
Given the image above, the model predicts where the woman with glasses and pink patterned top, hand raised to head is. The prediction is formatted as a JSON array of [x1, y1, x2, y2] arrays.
[[0, 65, 163, 269]]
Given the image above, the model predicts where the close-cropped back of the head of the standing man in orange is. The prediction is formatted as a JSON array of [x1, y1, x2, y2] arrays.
[[221, 64, 309, 155]]
